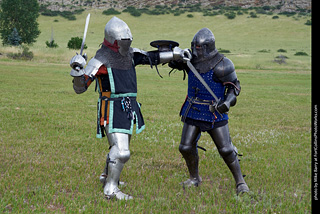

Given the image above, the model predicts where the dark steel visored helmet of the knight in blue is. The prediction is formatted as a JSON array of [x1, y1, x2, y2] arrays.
[[191, 28, 218, 59]]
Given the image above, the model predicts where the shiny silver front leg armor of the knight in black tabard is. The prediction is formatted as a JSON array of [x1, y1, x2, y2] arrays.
[[103, 133, 130, 199]]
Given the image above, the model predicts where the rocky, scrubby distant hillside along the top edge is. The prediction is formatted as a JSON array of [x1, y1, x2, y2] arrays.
[[37, 0, 311, 12]]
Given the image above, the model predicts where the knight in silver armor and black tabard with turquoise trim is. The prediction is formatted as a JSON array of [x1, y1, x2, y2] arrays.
[[70, 17, 189, 200]]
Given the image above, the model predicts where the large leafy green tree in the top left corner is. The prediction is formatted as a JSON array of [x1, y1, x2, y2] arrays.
[[0, 0, 40, 44]]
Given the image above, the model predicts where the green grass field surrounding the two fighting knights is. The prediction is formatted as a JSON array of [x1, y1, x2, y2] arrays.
[[0, 10, 311, 213]]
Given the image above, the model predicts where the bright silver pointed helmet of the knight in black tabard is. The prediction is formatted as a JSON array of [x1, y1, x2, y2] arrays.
[[104, 16, 132, 56]]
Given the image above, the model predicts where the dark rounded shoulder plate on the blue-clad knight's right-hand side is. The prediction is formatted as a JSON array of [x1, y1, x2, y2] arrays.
[[214, 57, 237, 82]]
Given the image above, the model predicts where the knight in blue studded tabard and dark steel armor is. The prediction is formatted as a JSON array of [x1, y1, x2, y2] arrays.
[[169, 28, 249, 194]]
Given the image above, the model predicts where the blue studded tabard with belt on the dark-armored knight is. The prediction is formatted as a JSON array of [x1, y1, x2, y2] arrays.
[[180, 69, 229, 123]]
